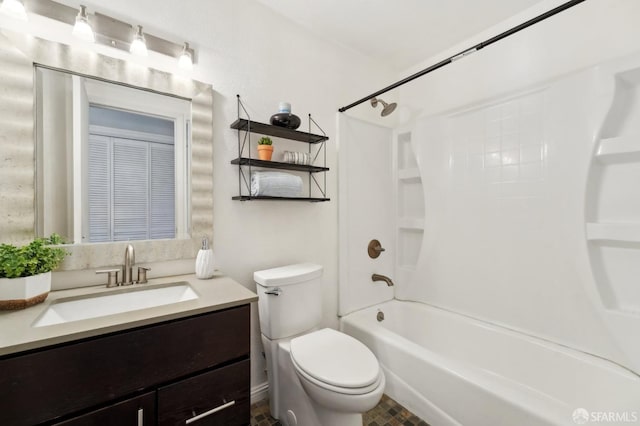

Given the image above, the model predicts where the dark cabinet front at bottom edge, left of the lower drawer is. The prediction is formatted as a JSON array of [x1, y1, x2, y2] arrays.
[[55, 392, 156, 426]]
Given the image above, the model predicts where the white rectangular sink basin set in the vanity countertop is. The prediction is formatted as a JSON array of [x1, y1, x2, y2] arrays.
[[33, 282, 198, 327]]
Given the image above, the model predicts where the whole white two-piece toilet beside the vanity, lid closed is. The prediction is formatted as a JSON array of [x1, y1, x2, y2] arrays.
[[253, 263, 385, 426]]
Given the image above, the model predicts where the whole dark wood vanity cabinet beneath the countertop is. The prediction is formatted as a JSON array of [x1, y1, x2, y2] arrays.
[[0, 305, 250, 426]]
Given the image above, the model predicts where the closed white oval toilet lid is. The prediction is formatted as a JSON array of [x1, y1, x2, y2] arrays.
[[290, 328, 380, 388]]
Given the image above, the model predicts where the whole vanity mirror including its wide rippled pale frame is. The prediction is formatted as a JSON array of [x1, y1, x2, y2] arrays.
[[0, 30, 213, 270]]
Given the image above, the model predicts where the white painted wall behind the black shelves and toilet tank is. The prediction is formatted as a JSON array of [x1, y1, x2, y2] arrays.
[[0, 0, 392, 392]]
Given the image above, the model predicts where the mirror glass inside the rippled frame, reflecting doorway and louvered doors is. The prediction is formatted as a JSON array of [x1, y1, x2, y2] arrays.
[[35, 65, 191, 243]]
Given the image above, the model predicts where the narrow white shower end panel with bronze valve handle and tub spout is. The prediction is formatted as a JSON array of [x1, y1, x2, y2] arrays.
[[338, 114, 395, 315]]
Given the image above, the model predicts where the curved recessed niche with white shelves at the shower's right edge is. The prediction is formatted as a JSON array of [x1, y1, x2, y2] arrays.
[[585, 54, 640, 371]]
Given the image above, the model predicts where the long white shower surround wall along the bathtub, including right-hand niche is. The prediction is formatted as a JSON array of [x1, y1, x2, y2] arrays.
[[396, 55, 640, 371]]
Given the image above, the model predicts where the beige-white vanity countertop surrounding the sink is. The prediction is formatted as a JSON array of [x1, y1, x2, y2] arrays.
[[0, 274, 258, 356]]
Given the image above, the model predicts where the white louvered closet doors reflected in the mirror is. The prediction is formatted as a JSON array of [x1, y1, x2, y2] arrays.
[[88, 134, 175, 242]]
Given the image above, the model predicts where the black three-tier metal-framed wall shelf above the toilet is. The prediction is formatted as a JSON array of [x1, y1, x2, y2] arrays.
[[230, 95, 330, 202]]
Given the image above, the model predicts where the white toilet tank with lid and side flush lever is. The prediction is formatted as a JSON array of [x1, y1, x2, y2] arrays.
[[253, 263, 322, 340]]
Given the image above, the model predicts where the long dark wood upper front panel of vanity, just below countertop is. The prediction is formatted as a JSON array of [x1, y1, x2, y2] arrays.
[[0, 305, 250, 425]]
